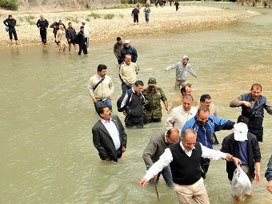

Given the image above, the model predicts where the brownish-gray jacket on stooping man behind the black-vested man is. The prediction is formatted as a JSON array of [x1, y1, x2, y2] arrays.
[[143, 131, 169, 169]]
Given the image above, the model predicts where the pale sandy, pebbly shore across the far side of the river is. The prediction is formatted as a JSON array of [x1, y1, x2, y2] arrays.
[[0, 4, 260, 47]]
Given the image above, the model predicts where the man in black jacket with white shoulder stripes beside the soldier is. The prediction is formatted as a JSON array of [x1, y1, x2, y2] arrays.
[[119, 80, 145, 128]]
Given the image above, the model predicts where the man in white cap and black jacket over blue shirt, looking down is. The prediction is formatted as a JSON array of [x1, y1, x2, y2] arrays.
[[221, 116, 261, 201]]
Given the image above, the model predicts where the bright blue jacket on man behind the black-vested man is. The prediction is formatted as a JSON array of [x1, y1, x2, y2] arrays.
[[181, 115, 234, 148]]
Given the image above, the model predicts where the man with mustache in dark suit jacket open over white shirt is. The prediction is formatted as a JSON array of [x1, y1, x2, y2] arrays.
[[92, 106, 127, 162]]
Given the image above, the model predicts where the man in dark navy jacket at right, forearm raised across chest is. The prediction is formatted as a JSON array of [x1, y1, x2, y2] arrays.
[[230, 84, 272, 142]]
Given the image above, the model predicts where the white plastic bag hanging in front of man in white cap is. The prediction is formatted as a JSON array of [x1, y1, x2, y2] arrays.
[[231, 167, 252, 197]]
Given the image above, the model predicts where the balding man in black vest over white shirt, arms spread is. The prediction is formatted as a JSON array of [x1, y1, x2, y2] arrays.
[[139, 129, 240, 204]]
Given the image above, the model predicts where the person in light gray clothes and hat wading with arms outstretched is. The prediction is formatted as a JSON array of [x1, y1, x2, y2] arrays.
[[165, 55, 197, 90]]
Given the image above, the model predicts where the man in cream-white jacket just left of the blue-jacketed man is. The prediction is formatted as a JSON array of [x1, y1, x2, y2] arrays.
[[166, 95, 197, 130]]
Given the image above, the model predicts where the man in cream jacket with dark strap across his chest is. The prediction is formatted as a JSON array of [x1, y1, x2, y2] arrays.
[[88, 64, 114, 111]]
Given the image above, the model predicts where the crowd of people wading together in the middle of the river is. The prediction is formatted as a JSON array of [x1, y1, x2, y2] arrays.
[[88, 37, 272, 204]]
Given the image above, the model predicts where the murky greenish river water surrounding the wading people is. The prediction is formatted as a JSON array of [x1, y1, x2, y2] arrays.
[[0, 3, 272, 204]]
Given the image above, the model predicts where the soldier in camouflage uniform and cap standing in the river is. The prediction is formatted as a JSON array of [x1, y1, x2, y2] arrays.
[[143, 77, 168, 123]]
